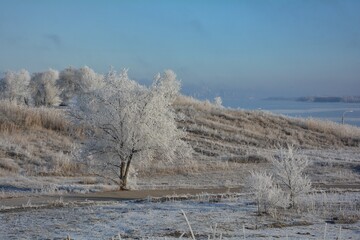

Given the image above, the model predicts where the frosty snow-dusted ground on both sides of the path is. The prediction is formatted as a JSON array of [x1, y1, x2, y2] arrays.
[[0, 149, 360, 239]]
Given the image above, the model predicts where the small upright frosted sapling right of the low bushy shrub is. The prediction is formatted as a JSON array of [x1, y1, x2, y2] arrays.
[[271, 146, 311, 207]]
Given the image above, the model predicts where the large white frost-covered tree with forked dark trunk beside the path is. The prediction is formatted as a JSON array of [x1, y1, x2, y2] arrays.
[[74, 70, 190, 189]]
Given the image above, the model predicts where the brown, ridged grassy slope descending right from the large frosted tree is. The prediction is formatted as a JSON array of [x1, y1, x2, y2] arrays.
[[174, 96, 360, 161]]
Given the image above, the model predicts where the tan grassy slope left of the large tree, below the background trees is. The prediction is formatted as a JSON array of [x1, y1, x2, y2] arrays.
[[0, 102, 79, 176]]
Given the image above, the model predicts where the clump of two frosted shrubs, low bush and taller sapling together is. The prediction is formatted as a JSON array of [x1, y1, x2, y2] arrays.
[[247, 147, 311, 213]]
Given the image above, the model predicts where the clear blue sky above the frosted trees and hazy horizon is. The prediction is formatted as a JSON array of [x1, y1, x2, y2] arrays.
[[0, 0, 360, 97]]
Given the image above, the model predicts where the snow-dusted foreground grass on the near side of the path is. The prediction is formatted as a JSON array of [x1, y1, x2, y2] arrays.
[[0, 193, 360, 239]]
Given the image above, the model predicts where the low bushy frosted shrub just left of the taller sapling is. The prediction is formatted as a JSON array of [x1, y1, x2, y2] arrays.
[[247, 171, 288, 214]]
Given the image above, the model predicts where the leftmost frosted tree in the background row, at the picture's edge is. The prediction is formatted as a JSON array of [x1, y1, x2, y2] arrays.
[[0, 69, 30, 104]]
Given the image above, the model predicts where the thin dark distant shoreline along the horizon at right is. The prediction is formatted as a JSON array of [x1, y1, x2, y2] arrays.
[[265, 96, 360, 103]]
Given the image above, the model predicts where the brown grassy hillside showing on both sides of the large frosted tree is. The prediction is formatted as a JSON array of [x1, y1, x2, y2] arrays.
[[0, 97, 360, 187]]
